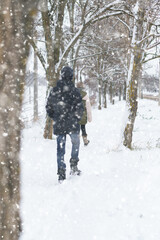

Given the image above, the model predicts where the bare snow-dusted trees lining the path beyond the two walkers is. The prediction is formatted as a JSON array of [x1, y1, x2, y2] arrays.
[[29, 0, 160, 148]]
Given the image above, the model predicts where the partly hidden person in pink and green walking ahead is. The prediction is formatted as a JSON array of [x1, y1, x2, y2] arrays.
[[77, 82, 92, 146]]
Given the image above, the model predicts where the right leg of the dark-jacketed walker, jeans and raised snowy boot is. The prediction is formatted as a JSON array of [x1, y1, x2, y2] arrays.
[[70, 133, 81, 175]]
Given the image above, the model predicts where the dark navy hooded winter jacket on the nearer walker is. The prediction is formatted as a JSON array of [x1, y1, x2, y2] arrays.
[[46, 67, 83, 135]]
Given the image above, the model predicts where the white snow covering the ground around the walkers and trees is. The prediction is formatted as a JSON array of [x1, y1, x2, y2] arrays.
[[21, 96, 160, 240]]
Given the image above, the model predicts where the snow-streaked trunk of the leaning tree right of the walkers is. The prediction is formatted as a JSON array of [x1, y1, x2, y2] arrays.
[[123, 1, 144, 149]]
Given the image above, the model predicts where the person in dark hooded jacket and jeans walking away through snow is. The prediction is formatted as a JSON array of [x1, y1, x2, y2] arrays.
[[46, 66, 84, 182]]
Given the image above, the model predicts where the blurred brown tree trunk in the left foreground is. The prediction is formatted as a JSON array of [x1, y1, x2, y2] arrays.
[[0, 0, 37, 240]]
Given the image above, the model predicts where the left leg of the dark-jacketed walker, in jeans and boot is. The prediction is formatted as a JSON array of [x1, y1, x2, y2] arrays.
[[57, 134, 66, 180]]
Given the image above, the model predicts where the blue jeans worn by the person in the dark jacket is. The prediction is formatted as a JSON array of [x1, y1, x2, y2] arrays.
[[57, 133, 80, 169]]
